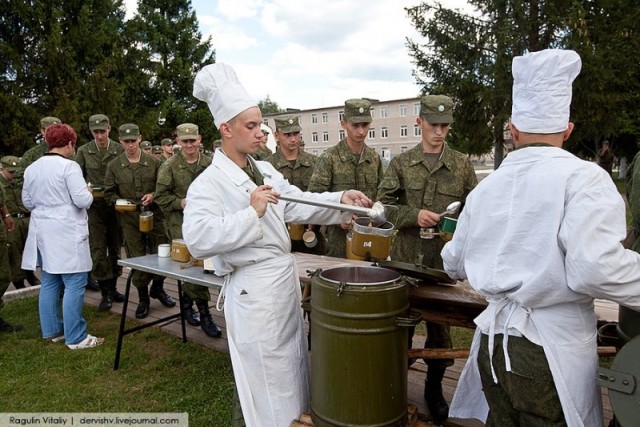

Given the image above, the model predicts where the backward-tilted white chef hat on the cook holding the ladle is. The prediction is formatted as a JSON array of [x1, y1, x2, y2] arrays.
[[193, 62, 257, 128]]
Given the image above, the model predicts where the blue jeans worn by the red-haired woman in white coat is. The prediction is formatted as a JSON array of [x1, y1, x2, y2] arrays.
[[38, 270, 87, 344]]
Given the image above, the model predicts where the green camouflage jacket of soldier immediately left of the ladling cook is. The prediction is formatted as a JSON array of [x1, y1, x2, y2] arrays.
[[155, 154, 212, 239]]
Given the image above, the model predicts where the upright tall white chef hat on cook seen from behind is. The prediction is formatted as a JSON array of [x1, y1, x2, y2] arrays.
[[511, 49, 582, 134]]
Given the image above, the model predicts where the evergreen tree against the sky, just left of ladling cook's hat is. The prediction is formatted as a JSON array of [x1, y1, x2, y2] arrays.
[[126, 0, 217, 141]]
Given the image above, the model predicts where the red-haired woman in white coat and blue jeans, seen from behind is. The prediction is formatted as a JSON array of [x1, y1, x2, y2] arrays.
[[22, 124, 104, 350]]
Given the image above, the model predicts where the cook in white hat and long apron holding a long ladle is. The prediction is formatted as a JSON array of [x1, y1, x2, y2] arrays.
[[182, 63, 372, 427]]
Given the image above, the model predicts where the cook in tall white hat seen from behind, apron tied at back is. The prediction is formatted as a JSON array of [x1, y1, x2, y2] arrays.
[[442, 50, 640, 426]]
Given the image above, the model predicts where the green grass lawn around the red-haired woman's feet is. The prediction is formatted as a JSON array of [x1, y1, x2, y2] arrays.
[[0, 297, 233, 427]]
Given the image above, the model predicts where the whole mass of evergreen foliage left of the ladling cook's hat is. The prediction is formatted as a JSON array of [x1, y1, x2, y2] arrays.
[[0, 0, 217, 156]]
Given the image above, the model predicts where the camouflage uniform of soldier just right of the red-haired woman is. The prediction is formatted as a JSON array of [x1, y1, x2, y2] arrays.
[[75, 139, 124, 282]]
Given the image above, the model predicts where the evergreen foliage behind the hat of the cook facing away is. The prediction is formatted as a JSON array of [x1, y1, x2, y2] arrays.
[[406, 0, 640, 164]]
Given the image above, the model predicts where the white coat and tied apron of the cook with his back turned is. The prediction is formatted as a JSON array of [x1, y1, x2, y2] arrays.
[[442, 147, 640, 427]]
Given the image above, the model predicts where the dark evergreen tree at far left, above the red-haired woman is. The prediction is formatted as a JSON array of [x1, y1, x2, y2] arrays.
[[0, 0, 124, 155]]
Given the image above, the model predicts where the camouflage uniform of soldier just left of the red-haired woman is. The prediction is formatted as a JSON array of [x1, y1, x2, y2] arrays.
[[0, 168, 33, 289]]
